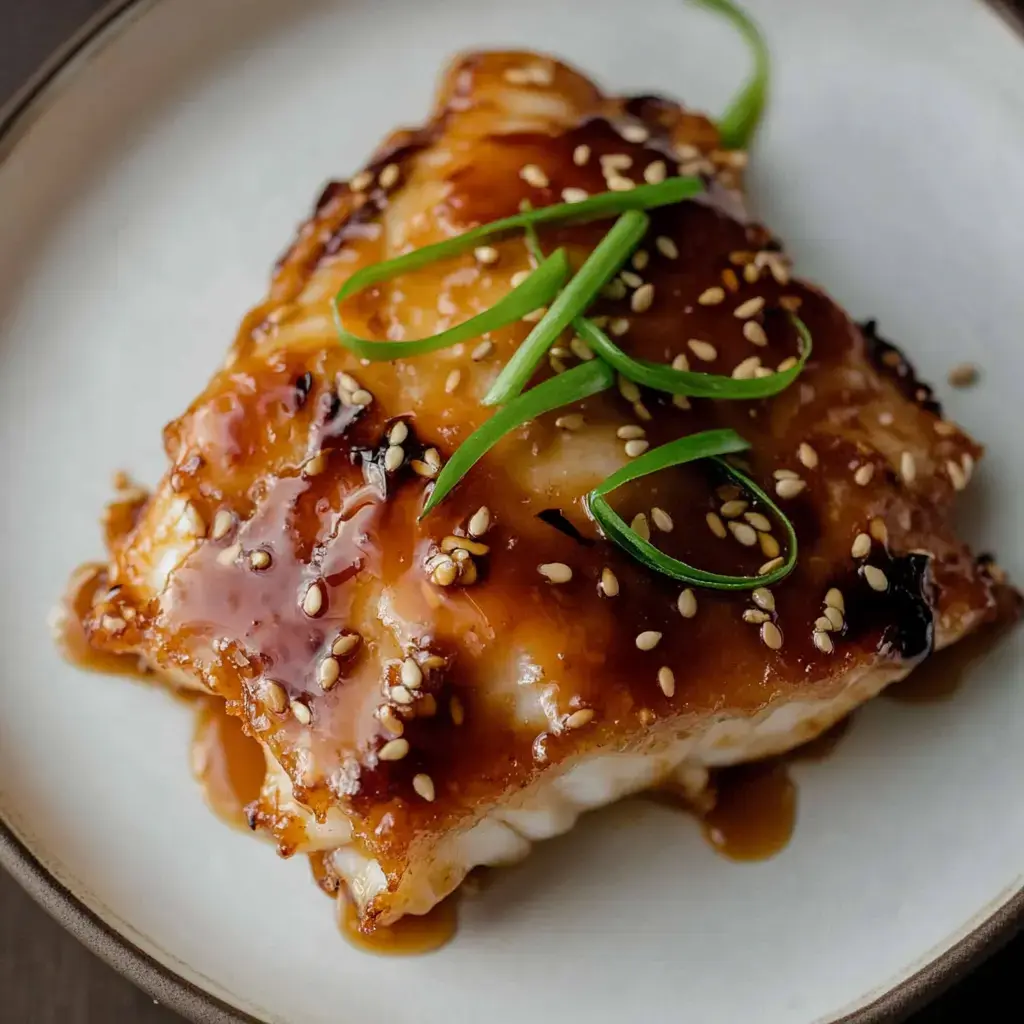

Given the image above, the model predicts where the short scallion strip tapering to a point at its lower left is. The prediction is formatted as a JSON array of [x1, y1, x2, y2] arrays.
[[420, 359, 615, 519]]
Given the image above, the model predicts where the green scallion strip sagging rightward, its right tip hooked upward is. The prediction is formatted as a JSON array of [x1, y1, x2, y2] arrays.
[[572, 316, 811, 399]]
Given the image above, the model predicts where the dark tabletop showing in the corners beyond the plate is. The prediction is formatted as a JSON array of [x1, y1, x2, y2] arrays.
[[0, 0, 1024, 1024]]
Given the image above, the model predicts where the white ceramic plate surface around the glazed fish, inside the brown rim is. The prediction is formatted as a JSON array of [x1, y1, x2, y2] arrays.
[[0, 0, 1024, 1024]]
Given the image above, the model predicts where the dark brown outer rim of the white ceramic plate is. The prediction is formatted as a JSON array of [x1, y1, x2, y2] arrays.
[[0, 0, 1024, 1024]]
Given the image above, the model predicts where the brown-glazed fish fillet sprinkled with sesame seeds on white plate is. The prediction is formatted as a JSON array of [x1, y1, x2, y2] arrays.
[[70, 52, 995, 929]]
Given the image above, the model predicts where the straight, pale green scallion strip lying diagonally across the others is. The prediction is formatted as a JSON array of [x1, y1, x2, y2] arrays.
[[483, 210, 650, 406]]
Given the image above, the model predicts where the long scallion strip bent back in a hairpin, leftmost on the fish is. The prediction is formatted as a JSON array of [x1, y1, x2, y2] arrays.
[[334, 177, 703, 359]]
